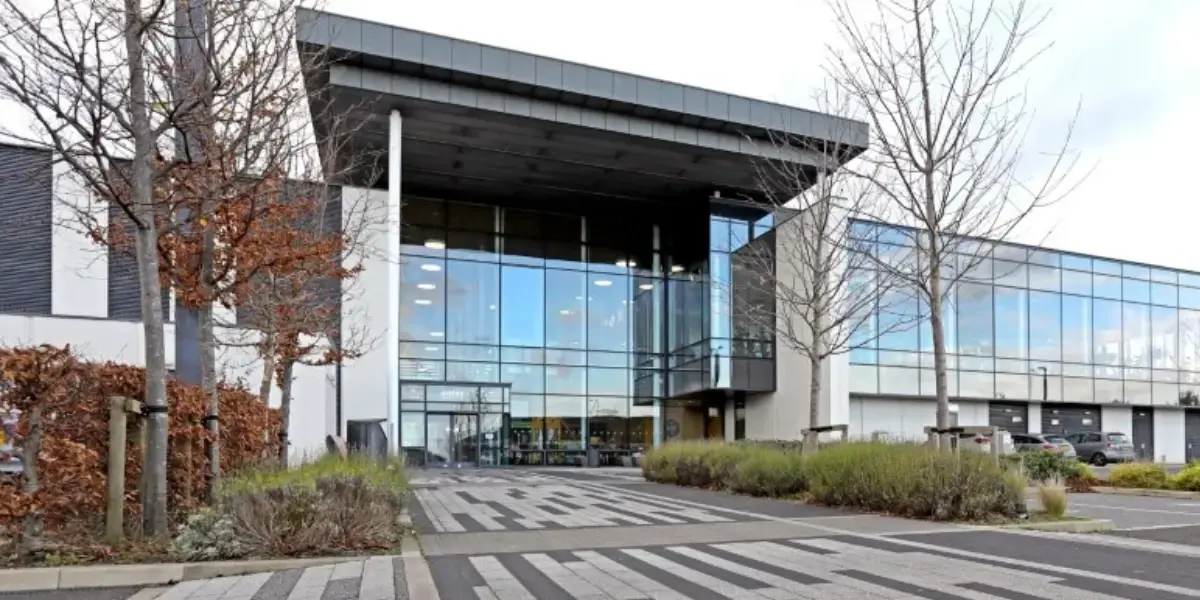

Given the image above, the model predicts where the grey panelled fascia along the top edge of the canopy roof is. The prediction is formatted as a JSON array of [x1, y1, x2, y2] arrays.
[[296, 8, 869, 149]]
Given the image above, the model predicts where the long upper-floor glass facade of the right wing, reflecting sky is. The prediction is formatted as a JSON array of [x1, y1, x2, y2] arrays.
[[851, 223, 1200, 406]]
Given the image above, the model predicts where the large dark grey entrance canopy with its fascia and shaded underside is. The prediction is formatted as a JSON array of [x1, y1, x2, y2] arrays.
[[298, 10, 868, 214]]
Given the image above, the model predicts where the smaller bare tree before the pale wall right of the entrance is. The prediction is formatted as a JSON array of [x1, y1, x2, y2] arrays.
[[730, 92, 916, 448]]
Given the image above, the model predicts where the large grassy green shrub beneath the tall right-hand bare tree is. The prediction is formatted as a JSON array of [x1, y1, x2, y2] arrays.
[[805, 442, 1025, 520]]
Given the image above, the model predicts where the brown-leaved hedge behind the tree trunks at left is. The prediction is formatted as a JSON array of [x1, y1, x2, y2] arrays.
[[0, 346, 280, 533]]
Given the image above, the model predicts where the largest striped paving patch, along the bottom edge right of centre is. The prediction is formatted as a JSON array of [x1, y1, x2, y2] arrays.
[[430, 538, 1160, 600]]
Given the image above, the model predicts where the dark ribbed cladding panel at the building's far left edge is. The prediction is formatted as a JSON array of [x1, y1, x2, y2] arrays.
[[0, 145, 54, 314]]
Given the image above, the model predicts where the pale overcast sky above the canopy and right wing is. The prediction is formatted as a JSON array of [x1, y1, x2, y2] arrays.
[[325, 0, 1200, 271]]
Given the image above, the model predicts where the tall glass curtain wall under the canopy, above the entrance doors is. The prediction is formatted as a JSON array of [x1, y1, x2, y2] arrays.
[[398, 198, 666, 464]]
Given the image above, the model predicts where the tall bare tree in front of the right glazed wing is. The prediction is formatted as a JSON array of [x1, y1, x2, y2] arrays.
[[828, 0, 1075, 444]]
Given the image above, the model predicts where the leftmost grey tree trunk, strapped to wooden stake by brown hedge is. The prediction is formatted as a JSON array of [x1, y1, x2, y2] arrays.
[[124, 0, 170, 536]]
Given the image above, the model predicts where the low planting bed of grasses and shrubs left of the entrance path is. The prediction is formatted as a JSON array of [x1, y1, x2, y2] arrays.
[[0, 455, 410, 566]]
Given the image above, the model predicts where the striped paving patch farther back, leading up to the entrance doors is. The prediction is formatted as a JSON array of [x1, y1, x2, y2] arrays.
[[414, 484, 744, 533]]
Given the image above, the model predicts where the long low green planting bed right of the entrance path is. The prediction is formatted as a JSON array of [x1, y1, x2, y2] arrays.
[[642, 442, 1026, 522]]
